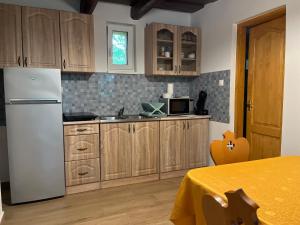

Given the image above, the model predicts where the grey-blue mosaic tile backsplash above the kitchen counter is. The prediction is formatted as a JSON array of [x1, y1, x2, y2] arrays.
[[62, 71, 230, 123]]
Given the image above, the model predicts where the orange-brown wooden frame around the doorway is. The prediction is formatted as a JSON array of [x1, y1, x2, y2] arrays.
[[234, 5, 286, 137]]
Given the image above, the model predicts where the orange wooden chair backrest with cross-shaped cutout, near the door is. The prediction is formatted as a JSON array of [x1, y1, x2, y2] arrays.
[[210, 131, 250, 165]]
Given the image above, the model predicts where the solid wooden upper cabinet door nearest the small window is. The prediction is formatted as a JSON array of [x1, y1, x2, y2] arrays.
[[60, 12, 95, 72]]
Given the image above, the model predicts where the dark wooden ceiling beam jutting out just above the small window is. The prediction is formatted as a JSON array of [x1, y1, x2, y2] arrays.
[[131, 0, 165, 20]]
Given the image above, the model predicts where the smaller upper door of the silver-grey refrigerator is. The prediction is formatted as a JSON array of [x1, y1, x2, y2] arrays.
[[4, 68, 62, 103]]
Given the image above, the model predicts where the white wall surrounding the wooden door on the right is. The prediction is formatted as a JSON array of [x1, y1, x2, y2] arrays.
[[191, 0, 300, 155]]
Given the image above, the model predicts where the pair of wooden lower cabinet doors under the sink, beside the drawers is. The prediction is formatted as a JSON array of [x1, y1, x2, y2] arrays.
[[100, 122, 159, 181]]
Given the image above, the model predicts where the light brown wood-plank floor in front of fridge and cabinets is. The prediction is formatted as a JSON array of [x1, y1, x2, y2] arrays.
[[1, 178, 182, 225]]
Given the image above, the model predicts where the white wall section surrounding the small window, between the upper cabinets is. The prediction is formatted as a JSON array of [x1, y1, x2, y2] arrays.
[[93, 1, 191, 73]]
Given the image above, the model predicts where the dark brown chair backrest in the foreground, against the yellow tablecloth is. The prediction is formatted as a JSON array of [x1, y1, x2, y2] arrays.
[[202, 189, 260, 225]]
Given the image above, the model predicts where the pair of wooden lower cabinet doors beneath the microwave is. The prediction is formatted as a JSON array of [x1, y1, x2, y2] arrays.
[[160, 119, 208, 173]]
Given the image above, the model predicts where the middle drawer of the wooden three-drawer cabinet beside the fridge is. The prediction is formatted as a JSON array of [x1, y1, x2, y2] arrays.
[[65, 134, 99, 161]]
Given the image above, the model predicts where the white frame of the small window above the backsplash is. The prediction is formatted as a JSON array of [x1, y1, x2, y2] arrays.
[[106, 23, 135, 73]]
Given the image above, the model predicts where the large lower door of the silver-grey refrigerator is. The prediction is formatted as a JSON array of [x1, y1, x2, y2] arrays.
[[6, 104, 65, 204]]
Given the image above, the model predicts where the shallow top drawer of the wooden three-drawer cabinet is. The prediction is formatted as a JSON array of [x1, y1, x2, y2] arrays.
[[64, 124, 99, 135]]
